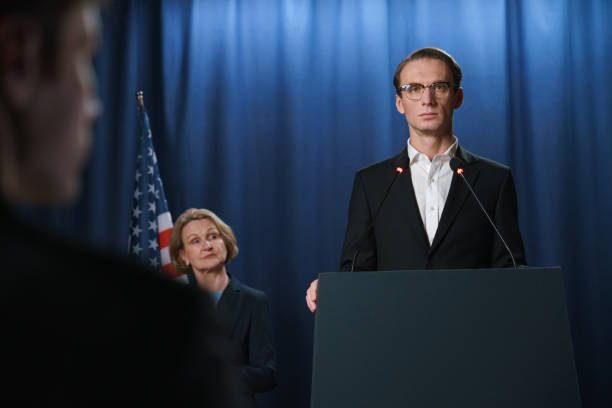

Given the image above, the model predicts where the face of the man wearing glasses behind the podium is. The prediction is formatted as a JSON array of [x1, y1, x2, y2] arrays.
[[395, 58, 463, 137]]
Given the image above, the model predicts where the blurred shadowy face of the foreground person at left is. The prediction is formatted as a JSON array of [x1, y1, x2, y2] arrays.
[[18, 2, 101, 203]]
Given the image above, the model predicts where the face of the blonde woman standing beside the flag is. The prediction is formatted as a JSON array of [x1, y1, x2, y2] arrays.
[[179, 219, 227, 272]]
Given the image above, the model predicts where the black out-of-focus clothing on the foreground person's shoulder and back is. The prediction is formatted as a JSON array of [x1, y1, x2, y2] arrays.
[[0, 201, 240, 407]]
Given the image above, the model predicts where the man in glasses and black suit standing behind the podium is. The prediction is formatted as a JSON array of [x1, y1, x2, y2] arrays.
[[306, 48, 526, 312]]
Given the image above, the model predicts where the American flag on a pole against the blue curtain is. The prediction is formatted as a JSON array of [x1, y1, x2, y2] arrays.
[[128, 92, 179, 278]]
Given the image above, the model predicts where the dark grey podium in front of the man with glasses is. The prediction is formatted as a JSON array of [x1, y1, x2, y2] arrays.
[[311, 268, 581, 408]]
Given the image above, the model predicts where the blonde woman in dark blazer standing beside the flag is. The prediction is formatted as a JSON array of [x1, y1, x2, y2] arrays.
[[170, 208, 278, 407]]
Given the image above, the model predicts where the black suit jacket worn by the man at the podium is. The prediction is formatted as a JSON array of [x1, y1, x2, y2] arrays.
[[340, 147, 526, 271]]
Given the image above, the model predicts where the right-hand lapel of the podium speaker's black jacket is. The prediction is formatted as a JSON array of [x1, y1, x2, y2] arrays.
[[430, 147, 479, 252]]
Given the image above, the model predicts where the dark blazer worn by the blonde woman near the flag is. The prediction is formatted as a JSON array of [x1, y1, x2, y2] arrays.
[[188, 274, 278, 407]]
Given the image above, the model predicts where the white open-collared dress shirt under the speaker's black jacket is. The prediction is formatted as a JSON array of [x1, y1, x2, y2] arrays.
[[408, 136, 458, 245]]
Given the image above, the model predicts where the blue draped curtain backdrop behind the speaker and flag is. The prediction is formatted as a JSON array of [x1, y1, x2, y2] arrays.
[[21, 0, 612, 407]]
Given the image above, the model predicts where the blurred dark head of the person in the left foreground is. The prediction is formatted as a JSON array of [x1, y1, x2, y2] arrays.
[[0, 0, 100, 204]]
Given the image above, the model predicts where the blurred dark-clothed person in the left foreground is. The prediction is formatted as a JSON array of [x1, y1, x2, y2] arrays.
[[0, 0, 235, 407]]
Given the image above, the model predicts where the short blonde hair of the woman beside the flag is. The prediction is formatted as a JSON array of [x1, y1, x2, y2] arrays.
[[170, 208, 243, 273]]
